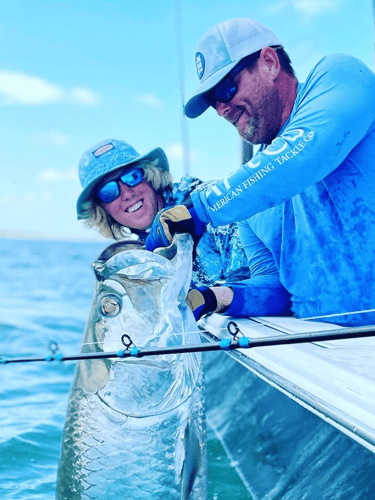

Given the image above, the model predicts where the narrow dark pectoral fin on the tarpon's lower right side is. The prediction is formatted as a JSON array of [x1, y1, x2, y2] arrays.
[[181, 423, 201, 500]]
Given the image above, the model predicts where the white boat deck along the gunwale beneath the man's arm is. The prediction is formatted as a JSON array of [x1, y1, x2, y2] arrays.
[[200, 314, 375, 452]]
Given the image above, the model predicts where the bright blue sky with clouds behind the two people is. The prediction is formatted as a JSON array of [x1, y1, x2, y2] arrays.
[[0, 0, 374, 237]]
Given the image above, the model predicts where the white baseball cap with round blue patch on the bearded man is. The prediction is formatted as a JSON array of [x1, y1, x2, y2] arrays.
[[185, 19, 283, 118]]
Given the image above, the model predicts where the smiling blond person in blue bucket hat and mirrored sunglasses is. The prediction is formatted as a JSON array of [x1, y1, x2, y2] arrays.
[[77, 139, 249, 312]]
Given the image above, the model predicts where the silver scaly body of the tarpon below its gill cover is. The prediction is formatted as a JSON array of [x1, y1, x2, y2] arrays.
[[57, 374, 205, 500]]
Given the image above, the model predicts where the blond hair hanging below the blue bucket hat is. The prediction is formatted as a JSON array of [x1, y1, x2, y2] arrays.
[[82, 160, 172, 240]]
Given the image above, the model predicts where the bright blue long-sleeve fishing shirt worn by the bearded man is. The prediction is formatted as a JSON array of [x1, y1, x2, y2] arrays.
[[192, 54, 375, 325]]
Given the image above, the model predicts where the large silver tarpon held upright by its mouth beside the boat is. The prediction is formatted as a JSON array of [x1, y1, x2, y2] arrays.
[[56, 234, 207, 500]]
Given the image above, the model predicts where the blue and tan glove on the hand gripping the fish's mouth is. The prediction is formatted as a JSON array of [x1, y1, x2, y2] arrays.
[[146, 205, 206, 251]]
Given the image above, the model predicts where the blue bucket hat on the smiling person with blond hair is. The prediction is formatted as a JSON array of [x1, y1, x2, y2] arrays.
[[77, 139, 169, 219]]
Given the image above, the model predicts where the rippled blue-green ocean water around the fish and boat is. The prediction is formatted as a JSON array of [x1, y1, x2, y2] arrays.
[[0, 239, 250, 500]]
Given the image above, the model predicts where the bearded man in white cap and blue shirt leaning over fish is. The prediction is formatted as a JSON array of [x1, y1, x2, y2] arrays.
[[146, 19, 375, 326]]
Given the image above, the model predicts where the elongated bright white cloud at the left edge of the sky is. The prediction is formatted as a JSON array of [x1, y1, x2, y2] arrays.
[[0, 70, 99, 106]]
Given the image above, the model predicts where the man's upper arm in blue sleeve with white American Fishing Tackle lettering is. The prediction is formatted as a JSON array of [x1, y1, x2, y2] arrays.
[[192, 55, 375, 227]]
